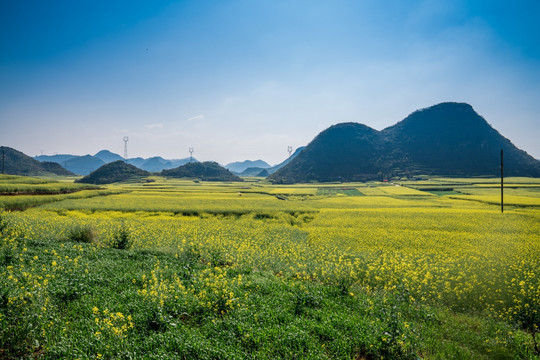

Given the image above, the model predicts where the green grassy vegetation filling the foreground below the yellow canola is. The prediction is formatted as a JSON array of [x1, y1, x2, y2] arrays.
[[0, 235, 529, 359]]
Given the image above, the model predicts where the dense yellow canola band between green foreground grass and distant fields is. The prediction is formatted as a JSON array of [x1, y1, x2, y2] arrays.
[[3, 198, 540, 326]]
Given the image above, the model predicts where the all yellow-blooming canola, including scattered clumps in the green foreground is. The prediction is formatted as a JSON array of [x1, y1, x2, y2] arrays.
[[0, 186, 540, 358]]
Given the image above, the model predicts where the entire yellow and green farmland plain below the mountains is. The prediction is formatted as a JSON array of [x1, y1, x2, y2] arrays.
[[0, 177, 540, 359]]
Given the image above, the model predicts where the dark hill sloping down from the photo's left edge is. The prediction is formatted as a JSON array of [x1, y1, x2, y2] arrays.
[[0, 146, 74, 176]]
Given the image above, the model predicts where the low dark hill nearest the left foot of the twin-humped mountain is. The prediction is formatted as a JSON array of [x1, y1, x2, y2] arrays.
[[161, 161, 243, 181]]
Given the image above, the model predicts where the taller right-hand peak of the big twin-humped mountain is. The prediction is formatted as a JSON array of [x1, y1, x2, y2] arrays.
[[382, 103, 540, 176]]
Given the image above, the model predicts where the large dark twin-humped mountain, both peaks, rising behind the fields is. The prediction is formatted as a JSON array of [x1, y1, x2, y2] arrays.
[[269, 103, 540, 183]]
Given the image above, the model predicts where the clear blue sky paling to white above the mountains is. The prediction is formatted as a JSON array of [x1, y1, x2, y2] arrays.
[[0, 0, 540, 164]]
